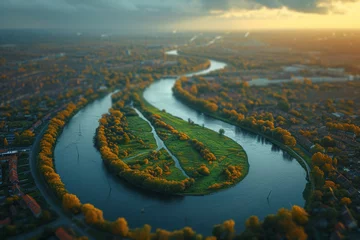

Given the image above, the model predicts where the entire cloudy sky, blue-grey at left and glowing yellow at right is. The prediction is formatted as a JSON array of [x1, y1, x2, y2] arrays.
[[0, 0, 360, 31]]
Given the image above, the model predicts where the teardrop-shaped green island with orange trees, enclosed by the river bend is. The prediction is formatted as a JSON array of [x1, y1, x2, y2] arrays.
[[97, 91, 249, 195]]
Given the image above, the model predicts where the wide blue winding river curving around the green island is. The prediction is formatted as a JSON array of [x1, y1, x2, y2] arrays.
[[55, 49, 307, 235]]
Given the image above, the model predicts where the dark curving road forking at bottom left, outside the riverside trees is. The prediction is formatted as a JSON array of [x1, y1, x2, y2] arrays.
[[9, 125, 93, 240]]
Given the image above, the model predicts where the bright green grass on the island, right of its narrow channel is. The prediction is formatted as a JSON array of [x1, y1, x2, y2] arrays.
[[139, 100, 249, 195]]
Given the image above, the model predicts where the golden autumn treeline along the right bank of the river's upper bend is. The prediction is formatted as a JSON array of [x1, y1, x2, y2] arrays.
[[173, 78, 296, 147]]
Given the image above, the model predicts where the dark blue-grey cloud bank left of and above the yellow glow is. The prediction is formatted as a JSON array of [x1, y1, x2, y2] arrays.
[[0, 0, 359, 31]]
